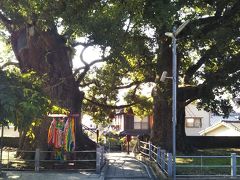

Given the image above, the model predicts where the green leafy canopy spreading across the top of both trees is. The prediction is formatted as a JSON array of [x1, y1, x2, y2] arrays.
[[0, 0, 240, 121]]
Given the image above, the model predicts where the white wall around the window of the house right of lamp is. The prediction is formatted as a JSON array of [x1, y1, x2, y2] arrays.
[[185, 104, 211, 136]]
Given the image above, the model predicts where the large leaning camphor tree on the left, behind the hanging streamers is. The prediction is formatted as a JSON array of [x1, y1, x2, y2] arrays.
[[0, 1, 99, 149]]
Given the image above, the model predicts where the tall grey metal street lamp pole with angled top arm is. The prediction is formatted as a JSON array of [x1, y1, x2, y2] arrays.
[[165, 20, 189, 180]]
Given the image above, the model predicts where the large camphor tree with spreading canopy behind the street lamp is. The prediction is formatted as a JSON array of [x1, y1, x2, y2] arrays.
[[75, 0, 240, 151]]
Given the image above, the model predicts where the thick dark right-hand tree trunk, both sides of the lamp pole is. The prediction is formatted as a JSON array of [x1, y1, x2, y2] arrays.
[[151, 36, 191, 152]]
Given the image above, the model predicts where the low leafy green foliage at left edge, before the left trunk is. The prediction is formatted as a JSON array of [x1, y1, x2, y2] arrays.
[[0, 70, 50, 131]]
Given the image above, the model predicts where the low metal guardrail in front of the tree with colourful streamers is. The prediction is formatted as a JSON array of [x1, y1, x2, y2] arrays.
[[0, 146, 106, 173]]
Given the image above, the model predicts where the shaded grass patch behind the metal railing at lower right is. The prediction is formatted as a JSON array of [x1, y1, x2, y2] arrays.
[[176, 148, 240, 175]]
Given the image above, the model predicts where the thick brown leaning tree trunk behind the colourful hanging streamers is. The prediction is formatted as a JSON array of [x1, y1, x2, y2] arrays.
[[11, 26, 95, 149]]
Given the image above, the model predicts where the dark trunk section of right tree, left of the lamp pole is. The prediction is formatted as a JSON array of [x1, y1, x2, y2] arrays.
[[151, 39, 172, 151]]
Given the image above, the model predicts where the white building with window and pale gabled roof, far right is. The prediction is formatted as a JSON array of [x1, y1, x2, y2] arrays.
[[185, 104, 240, 136]]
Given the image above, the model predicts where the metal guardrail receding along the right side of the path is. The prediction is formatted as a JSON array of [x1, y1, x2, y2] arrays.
[[139, 141, 173, 177]]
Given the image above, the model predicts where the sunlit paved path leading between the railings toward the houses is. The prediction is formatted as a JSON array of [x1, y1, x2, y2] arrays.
[[104, 153, 151, 180]]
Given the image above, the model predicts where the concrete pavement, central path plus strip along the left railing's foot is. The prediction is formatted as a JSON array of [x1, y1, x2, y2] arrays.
[[0, 152, 154, 180]]
